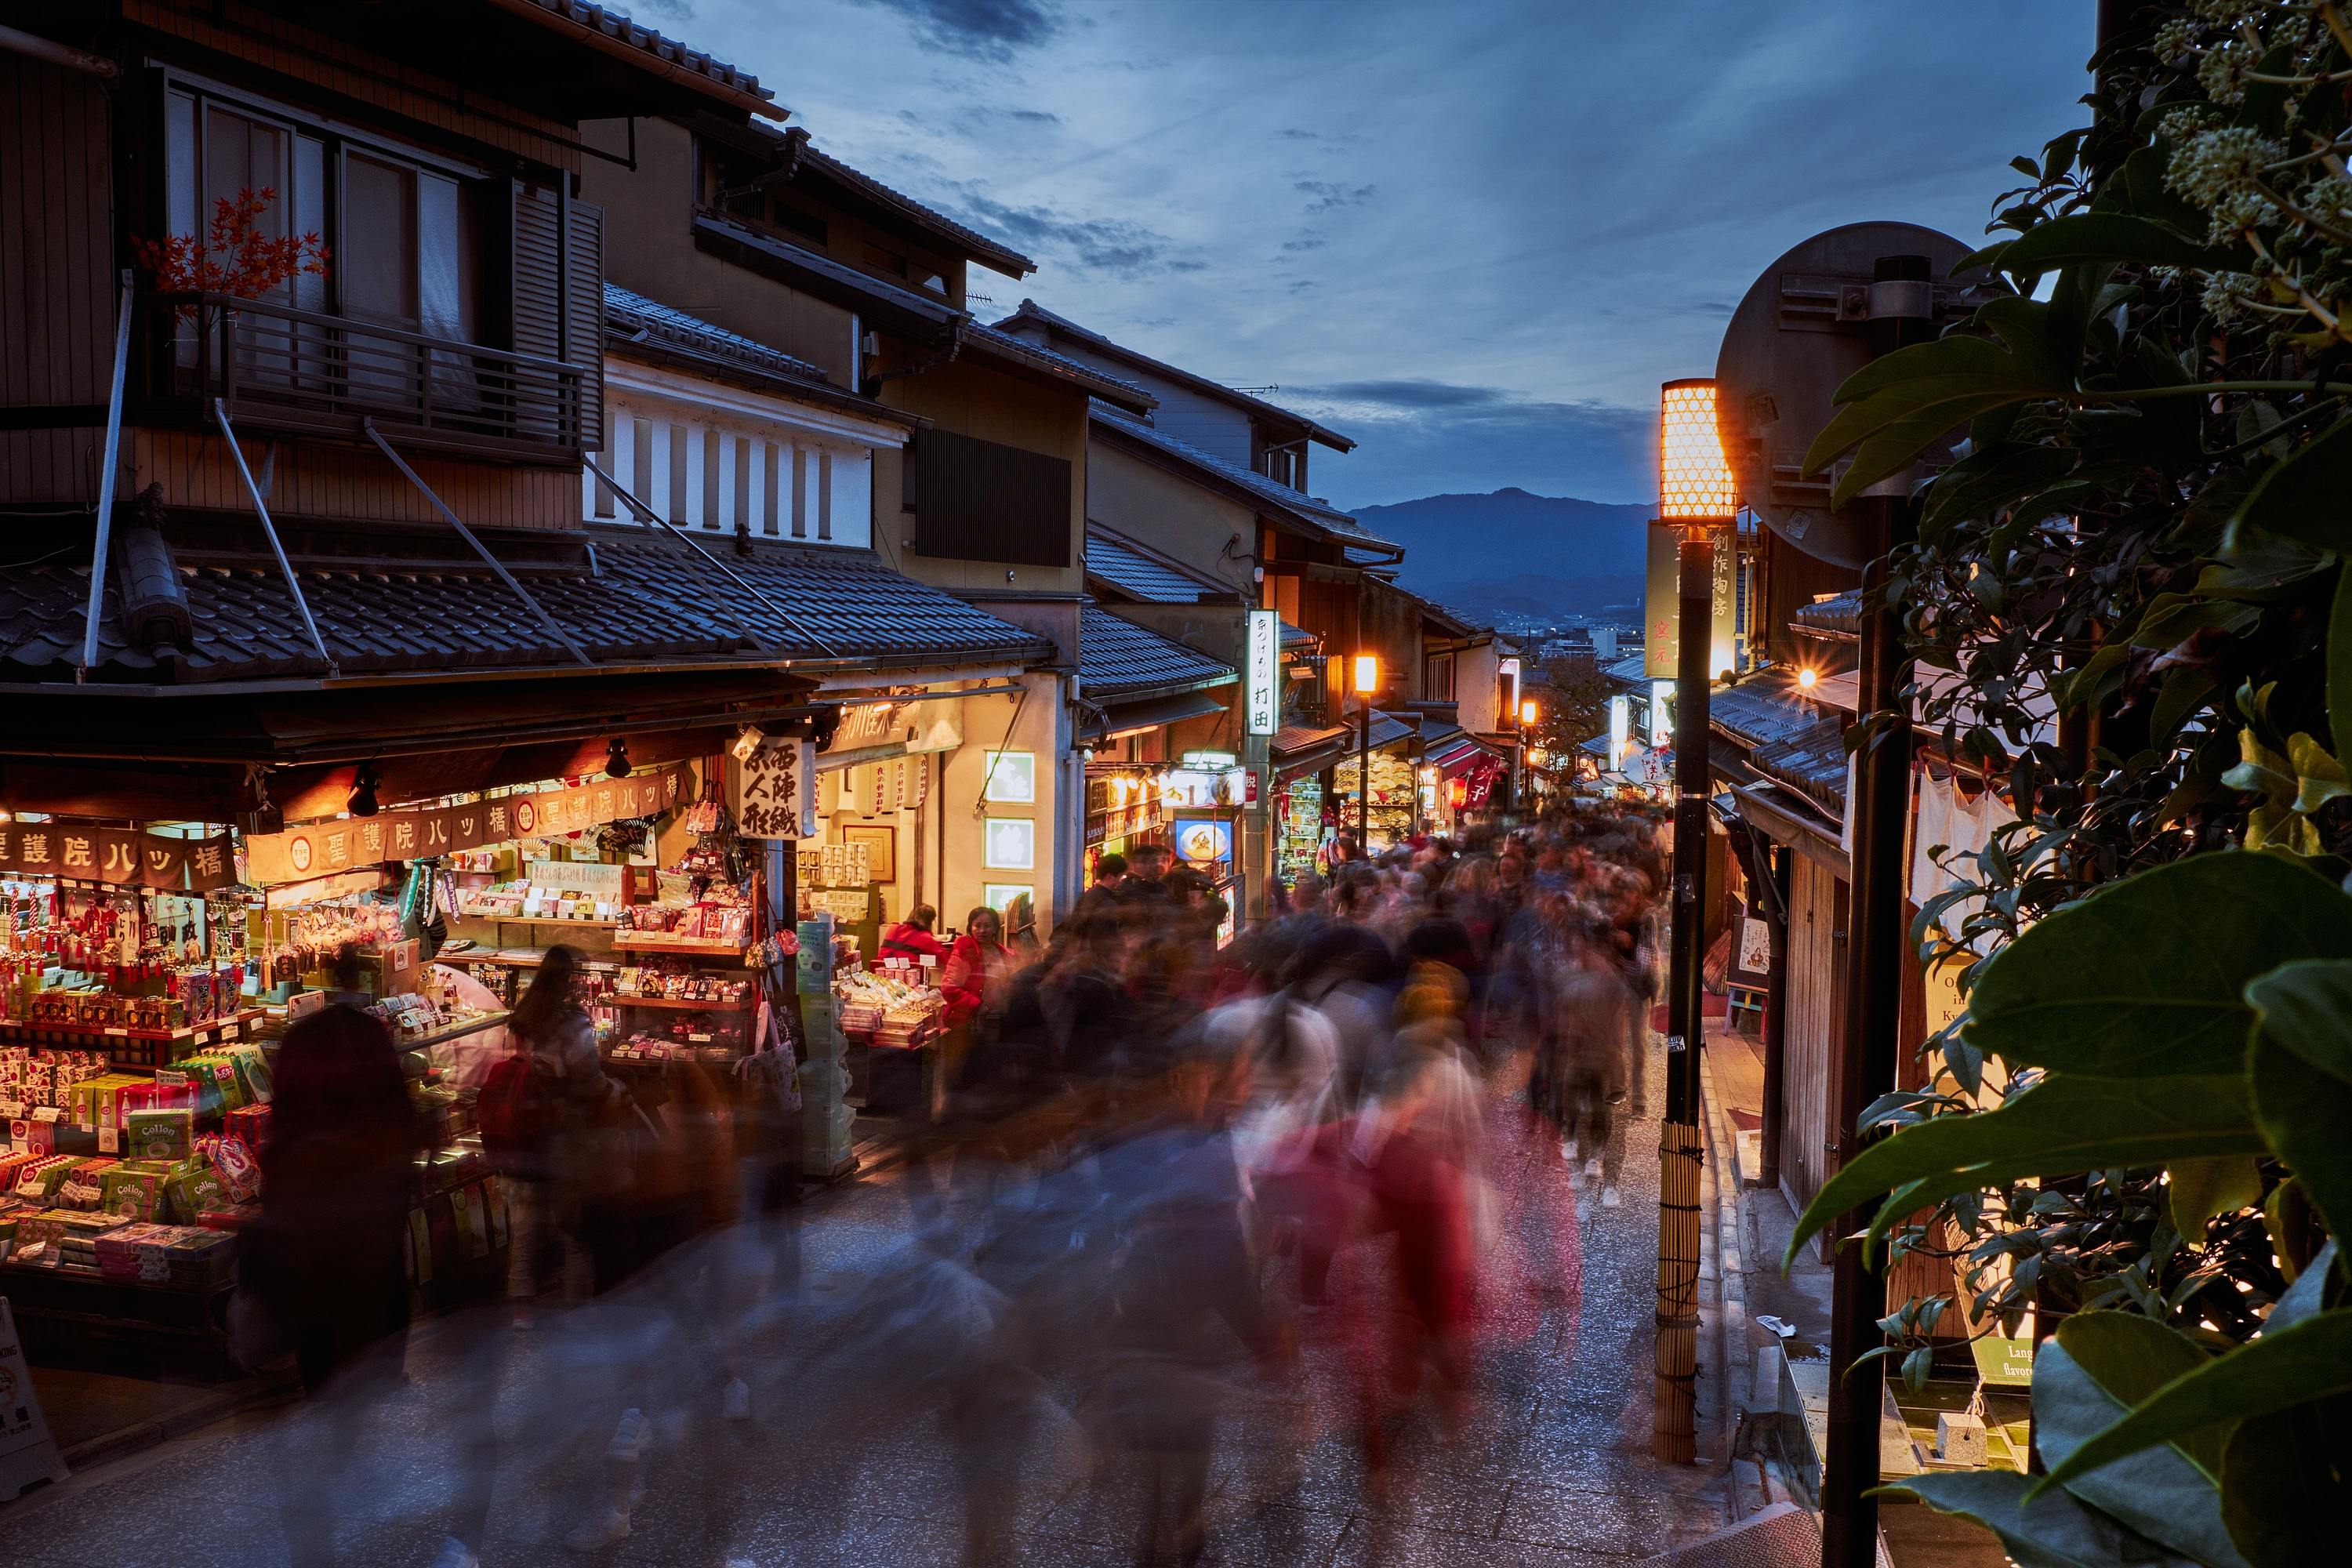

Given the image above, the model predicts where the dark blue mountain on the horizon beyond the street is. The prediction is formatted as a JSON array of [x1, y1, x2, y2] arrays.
[[1355, 487, 1651, 616]]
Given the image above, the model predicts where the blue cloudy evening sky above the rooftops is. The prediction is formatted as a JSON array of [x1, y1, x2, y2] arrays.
[[633, 0, 2093, 506]]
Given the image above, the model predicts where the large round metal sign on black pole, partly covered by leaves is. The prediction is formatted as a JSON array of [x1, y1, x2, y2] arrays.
[[1715, 223, 1985, 567]]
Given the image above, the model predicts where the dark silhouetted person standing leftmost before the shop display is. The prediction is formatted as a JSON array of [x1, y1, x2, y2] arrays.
[[238, 942, 426, 1568]]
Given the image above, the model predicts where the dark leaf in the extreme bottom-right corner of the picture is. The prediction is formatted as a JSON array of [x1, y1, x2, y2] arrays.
[[2220, 1399, 2352, 1568]]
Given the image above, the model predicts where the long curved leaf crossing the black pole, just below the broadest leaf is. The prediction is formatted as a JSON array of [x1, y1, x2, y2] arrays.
[[1788, 1072, 2265, 1260]]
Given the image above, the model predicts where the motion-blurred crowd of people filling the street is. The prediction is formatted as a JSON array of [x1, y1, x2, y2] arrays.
[[256, 806, 1665, 1568]]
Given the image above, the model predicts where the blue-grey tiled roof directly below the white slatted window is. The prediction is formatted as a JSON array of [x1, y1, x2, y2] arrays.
[[595, 529, 1051, 663]]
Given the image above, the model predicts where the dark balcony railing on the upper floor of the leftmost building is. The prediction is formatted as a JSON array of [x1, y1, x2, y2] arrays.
[[136, 294, 588, 461]]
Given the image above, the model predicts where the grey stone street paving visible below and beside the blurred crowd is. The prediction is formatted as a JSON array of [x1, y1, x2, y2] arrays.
[[0, 1029, 1724, 1568]]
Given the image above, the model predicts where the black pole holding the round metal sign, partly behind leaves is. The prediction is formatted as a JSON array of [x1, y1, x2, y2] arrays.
[[1820, 256, 1933, 1568]]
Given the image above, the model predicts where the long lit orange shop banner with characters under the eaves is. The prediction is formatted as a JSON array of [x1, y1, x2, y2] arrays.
[[245, 762, 694, 886]]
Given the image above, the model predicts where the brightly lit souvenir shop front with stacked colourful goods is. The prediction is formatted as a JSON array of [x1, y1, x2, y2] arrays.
[[0, 729, 983, 1370]]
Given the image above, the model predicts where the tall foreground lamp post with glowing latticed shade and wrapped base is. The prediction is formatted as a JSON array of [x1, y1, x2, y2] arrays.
[[1649, 381, 1738, 1465]]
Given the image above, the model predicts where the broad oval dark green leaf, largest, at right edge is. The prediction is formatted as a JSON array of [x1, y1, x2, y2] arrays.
[[1964, 851, 2352, 1079]]
